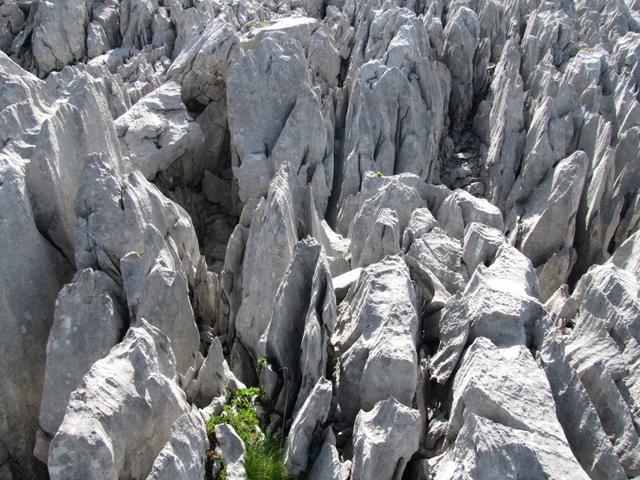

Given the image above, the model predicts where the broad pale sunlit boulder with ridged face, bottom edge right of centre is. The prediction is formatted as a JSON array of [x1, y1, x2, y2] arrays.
[[435, 338, 589, 480]]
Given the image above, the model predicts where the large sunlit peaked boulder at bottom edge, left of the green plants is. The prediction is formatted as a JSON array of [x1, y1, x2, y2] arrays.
[[49, 319, 189, 479]]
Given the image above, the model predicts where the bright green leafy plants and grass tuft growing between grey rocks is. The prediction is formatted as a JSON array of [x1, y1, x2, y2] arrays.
[[207, 387, 291, 480]]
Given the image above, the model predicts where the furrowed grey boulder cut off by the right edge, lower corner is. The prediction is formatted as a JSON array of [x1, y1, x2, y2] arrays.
[[566, 264, 640, 476]]
